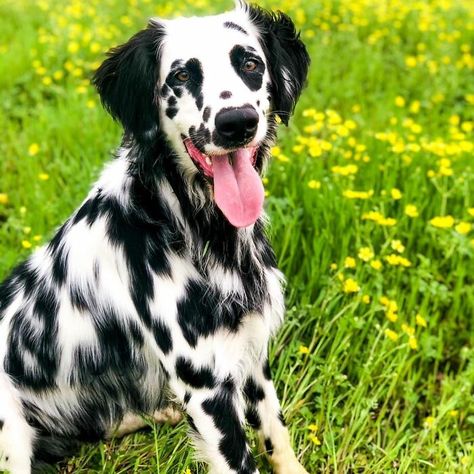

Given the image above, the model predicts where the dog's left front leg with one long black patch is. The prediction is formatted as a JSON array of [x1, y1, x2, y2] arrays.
[[170, 377, 259, 474]]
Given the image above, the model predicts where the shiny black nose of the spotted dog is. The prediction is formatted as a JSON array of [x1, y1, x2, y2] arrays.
[[215, 105, 258, 145]]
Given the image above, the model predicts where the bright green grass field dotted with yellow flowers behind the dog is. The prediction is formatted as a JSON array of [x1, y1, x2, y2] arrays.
[[0, 0, 474, 474]]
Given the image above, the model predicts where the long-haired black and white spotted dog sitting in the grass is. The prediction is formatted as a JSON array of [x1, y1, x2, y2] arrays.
[[0, 4, 309, 474]]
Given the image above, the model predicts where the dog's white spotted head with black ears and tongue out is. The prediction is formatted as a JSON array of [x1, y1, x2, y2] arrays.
[[94, 4, 309, 227]]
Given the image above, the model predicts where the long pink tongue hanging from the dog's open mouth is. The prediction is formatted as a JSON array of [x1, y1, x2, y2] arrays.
[[212, 148, 264, 227]]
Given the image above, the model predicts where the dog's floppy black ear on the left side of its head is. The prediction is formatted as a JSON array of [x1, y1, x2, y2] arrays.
[[92, 22, 164, 141]]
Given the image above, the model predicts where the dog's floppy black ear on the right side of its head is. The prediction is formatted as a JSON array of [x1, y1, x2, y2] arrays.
[[245, 5, 310, 125]]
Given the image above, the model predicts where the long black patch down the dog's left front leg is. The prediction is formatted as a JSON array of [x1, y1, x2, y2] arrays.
[[202, 389, 255, 473]]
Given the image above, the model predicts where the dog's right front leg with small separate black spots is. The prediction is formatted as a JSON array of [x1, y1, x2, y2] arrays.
[[244, 363, 308, 474]]
